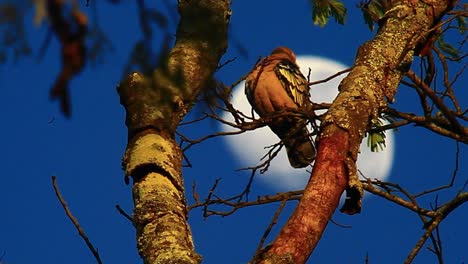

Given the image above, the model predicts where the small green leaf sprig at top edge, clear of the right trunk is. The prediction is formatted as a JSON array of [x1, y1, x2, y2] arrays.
[[310, 0, 346, 27]]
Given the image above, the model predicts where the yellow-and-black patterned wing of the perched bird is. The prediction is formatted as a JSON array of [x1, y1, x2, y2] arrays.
[[275, 60, 310, 107]]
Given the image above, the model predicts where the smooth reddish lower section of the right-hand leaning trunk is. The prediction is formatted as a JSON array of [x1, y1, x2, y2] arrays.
[[260, 126, 349, 263]]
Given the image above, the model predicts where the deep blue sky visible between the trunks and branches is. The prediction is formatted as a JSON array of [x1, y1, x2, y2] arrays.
[[0, 0, 468, 264]]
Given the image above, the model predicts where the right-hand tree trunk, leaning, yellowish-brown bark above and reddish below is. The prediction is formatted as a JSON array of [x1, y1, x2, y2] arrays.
[[258, 0, 454, 264]]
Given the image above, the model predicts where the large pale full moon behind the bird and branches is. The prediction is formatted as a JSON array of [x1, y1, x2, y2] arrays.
[[221, 56, 394, 191]]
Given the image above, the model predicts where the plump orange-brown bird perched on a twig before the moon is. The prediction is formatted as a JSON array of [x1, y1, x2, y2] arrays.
[[245, 47, 316, 168]]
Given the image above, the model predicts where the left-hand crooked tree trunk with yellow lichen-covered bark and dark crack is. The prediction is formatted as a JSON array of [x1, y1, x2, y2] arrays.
[[118, 0, 230, 264]]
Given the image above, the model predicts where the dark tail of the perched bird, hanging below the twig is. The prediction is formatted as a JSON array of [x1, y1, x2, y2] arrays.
[[284, 128, 316, 168]]
